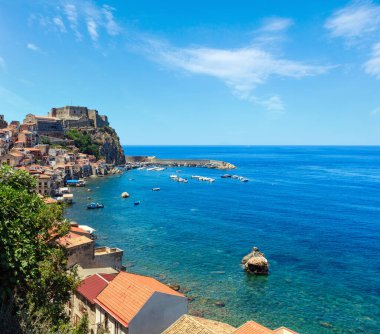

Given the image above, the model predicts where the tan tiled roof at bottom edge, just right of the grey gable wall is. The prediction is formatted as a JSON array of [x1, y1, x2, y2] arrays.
[[162, 314, 236, 334]]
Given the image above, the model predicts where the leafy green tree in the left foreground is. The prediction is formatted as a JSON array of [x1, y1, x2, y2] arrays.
[[0, 165, 78, 333]]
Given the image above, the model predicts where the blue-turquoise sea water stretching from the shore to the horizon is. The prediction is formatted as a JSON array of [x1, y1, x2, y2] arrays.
[[67, 146, 380, 333]]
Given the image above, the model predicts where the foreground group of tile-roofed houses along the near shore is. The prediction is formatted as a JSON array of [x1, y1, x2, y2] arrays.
[[56, 224, 296, 334]]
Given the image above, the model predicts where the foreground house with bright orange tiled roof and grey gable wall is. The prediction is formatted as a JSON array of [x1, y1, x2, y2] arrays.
[[95, 272, 187, 334]]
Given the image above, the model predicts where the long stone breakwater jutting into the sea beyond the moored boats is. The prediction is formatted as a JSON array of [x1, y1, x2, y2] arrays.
[[126, 156, 236, 169]]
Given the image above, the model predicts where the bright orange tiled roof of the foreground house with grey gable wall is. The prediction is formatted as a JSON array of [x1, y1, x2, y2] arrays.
[[95, 272, 185, 327]]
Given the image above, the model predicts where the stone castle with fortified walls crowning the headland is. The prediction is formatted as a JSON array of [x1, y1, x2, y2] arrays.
[[49, 106, 109, 129]]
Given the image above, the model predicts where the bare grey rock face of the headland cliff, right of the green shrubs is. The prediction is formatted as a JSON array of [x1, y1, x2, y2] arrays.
[[77, 126, 125, 165]]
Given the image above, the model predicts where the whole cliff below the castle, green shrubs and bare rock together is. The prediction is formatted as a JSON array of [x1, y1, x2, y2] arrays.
[[65, 126, 125, 165]]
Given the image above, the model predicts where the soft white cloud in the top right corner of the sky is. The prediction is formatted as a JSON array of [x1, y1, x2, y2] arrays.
[[325, 1, 380, 44]]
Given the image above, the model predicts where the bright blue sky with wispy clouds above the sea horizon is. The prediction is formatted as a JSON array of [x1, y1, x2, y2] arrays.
[[0, 0, 380, 145]]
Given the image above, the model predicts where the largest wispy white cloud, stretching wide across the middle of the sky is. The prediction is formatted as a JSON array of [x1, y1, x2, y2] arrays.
[[144, 39, 329, 111]]
